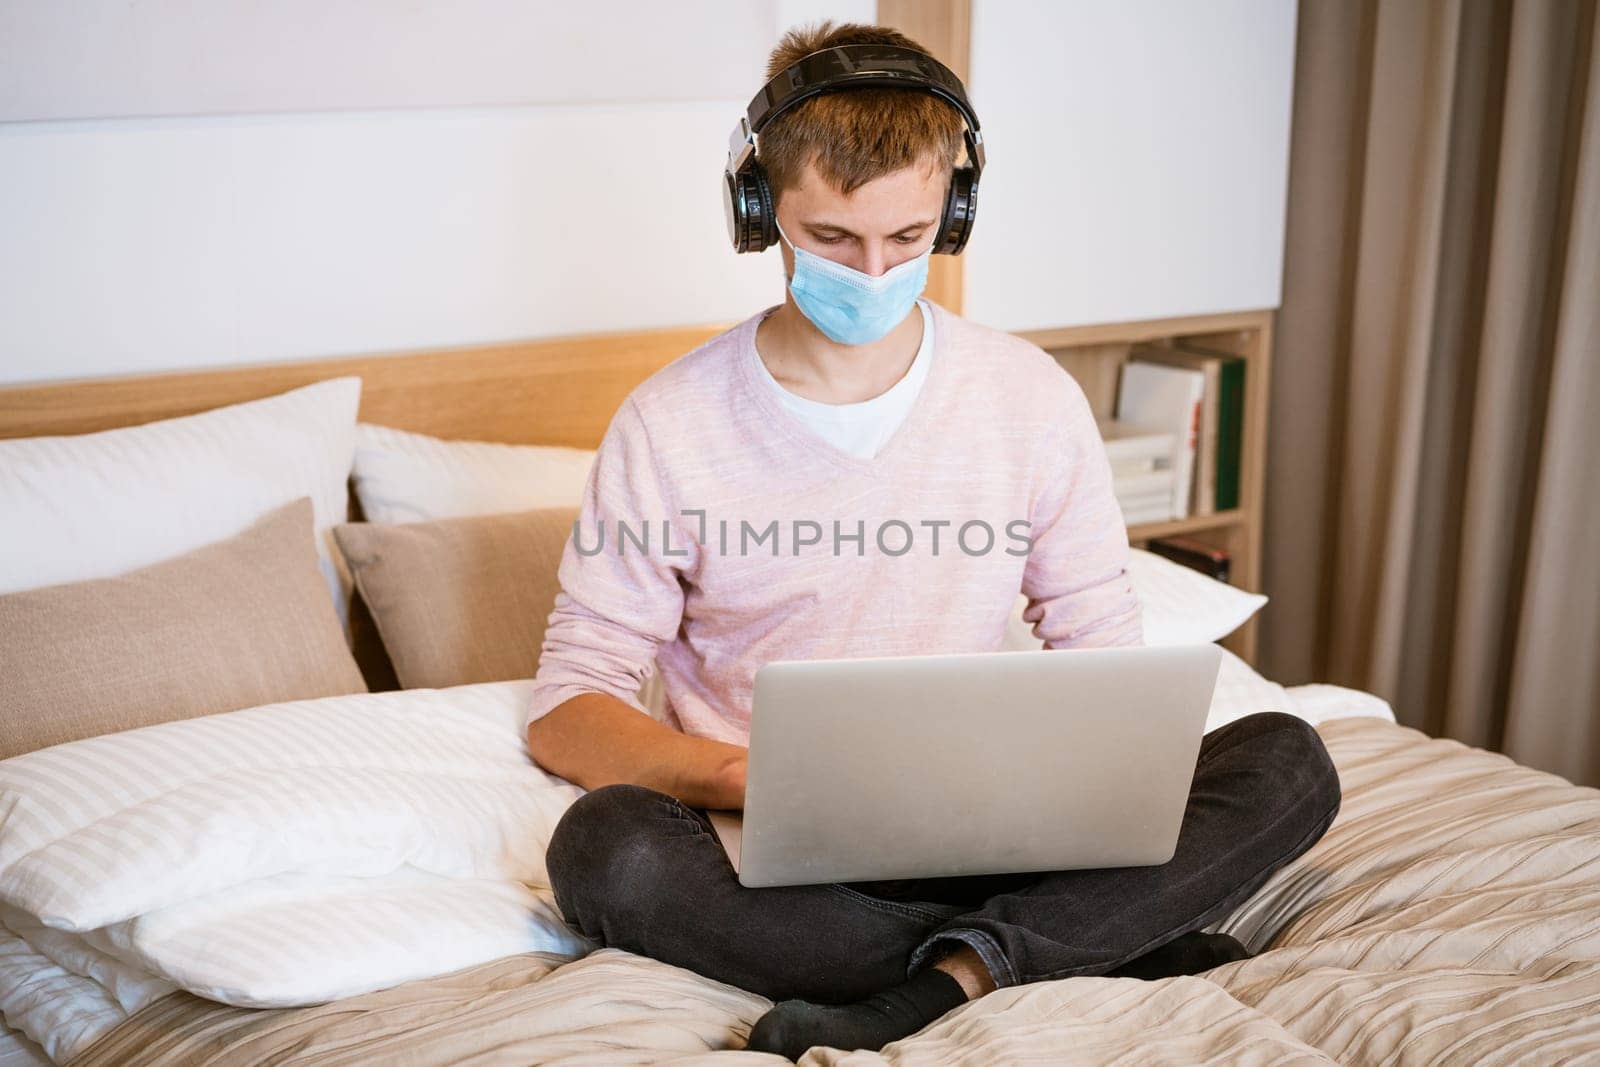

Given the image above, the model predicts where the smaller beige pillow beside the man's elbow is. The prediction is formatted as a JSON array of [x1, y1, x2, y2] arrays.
[[333, 507, 578, 689]]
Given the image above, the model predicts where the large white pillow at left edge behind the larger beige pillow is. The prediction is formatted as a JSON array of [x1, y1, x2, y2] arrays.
[[0, 378, 362, 621]]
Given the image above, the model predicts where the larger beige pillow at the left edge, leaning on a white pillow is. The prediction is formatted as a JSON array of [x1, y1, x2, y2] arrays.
[[0, 496, 366, 758]]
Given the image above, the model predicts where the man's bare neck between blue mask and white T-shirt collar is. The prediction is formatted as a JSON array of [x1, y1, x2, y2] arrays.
[[755, 296, 922, 403]]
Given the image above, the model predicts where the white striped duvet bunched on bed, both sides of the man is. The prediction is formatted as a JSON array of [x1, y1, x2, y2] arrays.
[[0, 668, 1392, 1062]]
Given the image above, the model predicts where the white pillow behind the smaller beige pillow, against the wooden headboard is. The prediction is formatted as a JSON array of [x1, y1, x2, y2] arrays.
[[354, 422, 595, 523]]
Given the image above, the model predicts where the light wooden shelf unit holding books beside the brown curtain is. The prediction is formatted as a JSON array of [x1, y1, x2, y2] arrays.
[[1018, 303, 1272, 665]]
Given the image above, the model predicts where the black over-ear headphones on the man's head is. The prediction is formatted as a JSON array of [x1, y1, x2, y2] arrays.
[[723, 45, 984, 256]]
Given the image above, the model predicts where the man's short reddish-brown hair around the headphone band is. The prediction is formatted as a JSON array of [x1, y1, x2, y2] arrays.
[[757, 21, 966, 202]]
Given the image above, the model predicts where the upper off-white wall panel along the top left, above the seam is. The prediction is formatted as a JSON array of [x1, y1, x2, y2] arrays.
[[0, 0, 782, 122]]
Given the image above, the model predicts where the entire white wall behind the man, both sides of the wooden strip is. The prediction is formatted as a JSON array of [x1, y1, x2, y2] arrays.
[[0, 0, 1294, 382]]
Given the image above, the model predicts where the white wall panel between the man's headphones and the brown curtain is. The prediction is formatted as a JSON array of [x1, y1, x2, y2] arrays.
[[965, 0, 1296, 330]]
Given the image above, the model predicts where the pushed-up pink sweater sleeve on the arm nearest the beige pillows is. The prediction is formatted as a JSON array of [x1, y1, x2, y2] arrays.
[[528, 397, 699, 723]]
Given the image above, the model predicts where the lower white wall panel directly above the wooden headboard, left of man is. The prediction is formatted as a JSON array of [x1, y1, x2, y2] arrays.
[[0, 101, 782, 381]]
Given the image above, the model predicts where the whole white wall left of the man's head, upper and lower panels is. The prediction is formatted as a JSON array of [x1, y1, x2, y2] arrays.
[[0, 0, 875, 382]]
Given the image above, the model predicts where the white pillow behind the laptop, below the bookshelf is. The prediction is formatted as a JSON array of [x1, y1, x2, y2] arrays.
[[1002, 549, 1267, 649]]
